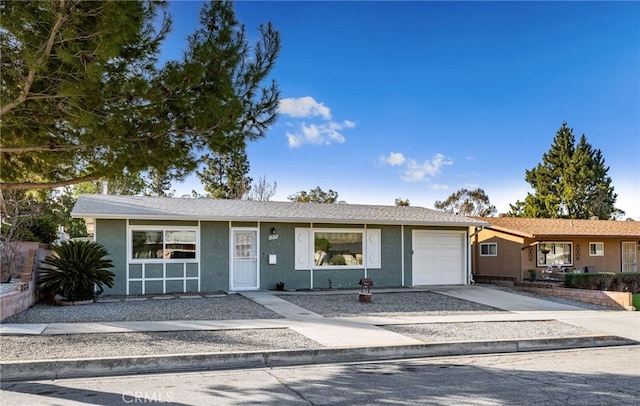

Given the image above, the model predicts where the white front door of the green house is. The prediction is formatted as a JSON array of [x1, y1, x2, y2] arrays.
[[229, 228, 259, 290]]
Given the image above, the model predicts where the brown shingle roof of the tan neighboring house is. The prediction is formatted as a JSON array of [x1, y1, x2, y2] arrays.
[[476, 217, 640, 238]]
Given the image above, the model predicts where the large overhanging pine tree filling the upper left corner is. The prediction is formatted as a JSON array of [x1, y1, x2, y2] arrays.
[[0, 0, 280, 190]]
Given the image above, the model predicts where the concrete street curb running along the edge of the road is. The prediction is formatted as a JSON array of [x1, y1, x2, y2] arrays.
[[0, 336, 638, 382]]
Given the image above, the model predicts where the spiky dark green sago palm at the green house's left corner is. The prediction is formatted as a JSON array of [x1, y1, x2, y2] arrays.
[[40, 241, 115, 302]]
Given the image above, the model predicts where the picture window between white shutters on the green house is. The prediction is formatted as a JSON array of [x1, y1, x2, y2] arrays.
[[313, 231, 363, 267]]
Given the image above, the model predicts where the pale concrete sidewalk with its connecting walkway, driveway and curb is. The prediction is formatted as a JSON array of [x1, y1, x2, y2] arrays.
[[0, 286, 640, 380]]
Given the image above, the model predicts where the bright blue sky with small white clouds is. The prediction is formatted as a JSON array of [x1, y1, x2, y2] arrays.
[[163, 1, 640, 220]]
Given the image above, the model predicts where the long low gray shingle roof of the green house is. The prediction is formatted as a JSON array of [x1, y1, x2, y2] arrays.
[[71, 195, 488, 227]]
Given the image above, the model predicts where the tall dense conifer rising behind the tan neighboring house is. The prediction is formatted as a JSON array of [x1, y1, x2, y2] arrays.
[[509, 123, 617, 219]]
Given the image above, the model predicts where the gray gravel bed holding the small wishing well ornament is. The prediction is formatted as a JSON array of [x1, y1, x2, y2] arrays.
[[278, 292, 504, 317]]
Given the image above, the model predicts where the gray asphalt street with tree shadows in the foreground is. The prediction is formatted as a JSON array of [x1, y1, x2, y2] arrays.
[[0, 346, 640, 406]]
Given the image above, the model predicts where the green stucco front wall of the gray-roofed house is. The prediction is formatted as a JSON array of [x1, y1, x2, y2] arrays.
[[91, 220, 470, 295]]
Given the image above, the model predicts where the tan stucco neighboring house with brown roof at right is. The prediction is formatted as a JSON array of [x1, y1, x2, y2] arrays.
[[471, 217, 640, 280]]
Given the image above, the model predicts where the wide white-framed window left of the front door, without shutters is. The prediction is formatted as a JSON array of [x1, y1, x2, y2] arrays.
[[131, 229, 196, 260]]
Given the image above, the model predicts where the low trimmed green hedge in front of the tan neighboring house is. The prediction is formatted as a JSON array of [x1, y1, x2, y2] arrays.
[[564, 272, 640, 293]]
